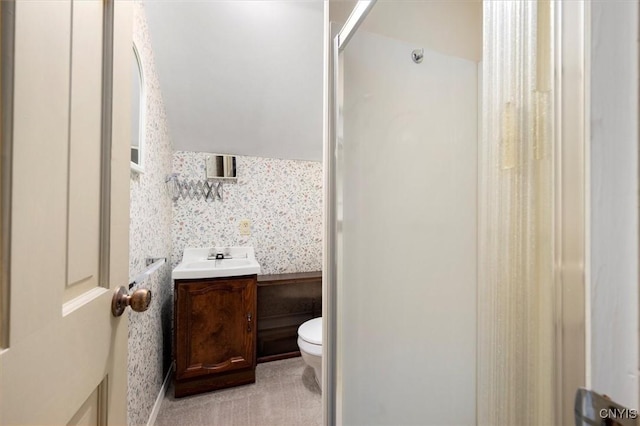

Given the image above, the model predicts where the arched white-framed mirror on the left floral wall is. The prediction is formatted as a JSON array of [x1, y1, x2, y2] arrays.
[[131, 43, 146, 173]]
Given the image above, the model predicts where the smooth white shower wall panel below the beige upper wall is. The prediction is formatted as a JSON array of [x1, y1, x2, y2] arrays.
[[337, 28, 478, 425]]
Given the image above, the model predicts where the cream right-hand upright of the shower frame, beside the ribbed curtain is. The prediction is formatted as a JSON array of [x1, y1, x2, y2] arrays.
[[553, 1, 591, 424]]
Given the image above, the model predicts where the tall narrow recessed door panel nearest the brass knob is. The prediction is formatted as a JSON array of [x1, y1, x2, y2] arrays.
[[65, 1, 104, 300]]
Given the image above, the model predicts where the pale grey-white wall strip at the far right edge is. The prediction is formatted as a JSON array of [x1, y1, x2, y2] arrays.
[[590, 1, 639, 408]]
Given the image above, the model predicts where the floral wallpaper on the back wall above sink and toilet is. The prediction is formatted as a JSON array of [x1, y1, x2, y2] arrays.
[[172, 151, 322, 274]]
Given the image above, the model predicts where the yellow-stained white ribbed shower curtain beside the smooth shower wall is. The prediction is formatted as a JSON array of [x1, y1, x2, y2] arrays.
[[478, 0, 555, 426]]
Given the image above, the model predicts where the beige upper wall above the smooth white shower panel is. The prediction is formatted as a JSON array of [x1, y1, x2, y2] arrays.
[[329, 0, 482, 62]]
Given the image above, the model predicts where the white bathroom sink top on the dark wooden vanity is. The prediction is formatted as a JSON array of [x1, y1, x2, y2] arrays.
[[171, 247, 260, 279]]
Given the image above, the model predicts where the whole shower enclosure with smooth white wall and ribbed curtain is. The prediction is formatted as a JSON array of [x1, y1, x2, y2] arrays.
[[323, 1, 584, 425]]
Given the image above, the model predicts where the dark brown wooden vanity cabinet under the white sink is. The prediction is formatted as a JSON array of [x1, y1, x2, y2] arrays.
[[173, 275, 257, 397]]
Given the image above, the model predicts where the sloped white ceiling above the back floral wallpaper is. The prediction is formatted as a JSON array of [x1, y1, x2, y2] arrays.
[[145, 0, 323, 161]]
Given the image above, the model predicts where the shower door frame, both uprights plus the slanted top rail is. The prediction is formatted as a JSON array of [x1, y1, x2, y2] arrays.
[[322, 0, 590, 425]]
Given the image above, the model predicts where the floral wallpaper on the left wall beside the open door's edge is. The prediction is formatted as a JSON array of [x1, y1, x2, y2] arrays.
[[127, 1, 173, 425]]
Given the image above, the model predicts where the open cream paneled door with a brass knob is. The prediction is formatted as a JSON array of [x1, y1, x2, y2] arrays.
[[0, 0, 132, 425]]
